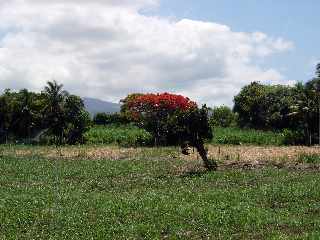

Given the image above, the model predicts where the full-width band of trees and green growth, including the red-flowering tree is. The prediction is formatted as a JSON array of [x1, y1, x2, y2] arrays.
[[0, 64, 320, 169]]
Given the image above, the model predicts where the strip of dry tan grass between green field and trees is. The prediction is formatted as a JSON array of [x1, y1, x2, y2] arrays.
[[1, 145, 320, 165]]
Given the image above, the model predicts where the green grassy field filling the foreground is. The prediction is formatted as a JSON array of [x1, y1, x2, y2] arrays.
[[0, 149, 320, 239]]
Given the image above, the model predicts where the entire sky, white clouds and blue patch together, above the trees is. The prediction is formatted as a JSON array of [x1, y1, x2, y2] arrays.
[[0, 0, 320, 106]]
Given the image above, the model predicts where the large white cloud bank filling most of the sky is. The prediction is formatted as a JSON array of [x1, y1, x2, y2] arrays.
[[0, 0, 293, 105]]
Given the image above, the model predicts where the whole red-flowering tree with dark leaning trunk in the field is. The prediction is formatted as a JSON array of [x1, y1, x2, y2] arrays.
[[122, 93, 216, 170]]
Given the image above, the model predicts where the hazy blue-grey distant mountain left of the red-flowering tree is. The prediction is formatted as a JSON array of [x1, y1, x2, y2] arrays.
[[83, 98, 121, 116]]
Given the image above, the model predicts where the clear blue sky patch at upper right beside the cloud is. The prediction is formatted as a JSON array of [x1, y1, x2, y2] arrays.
[[157, 0, 320, 81]]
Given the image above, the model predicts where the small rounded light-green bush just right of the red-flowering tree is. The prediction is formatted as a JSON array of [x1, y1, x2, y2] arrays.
[[209, 106, 236, 127]]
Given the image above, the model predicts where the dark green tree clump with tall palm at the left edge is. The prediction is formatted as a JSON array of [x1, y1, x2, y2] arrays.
[[0, 81, 91, 144]]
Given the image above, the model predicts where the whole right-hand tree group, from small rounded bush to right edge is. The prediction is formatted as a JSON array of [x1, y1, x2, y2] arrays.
[[211, 64, 320, 145]]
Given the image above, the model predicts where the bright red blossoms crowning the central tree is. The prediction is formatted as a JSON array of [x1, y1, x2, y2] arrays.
[[128, 93, 197, 112]]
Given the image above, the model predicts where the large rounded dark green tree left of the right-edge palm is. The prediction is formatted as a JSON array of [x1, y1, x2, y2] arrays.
[[234, 82, 298, 130]]
